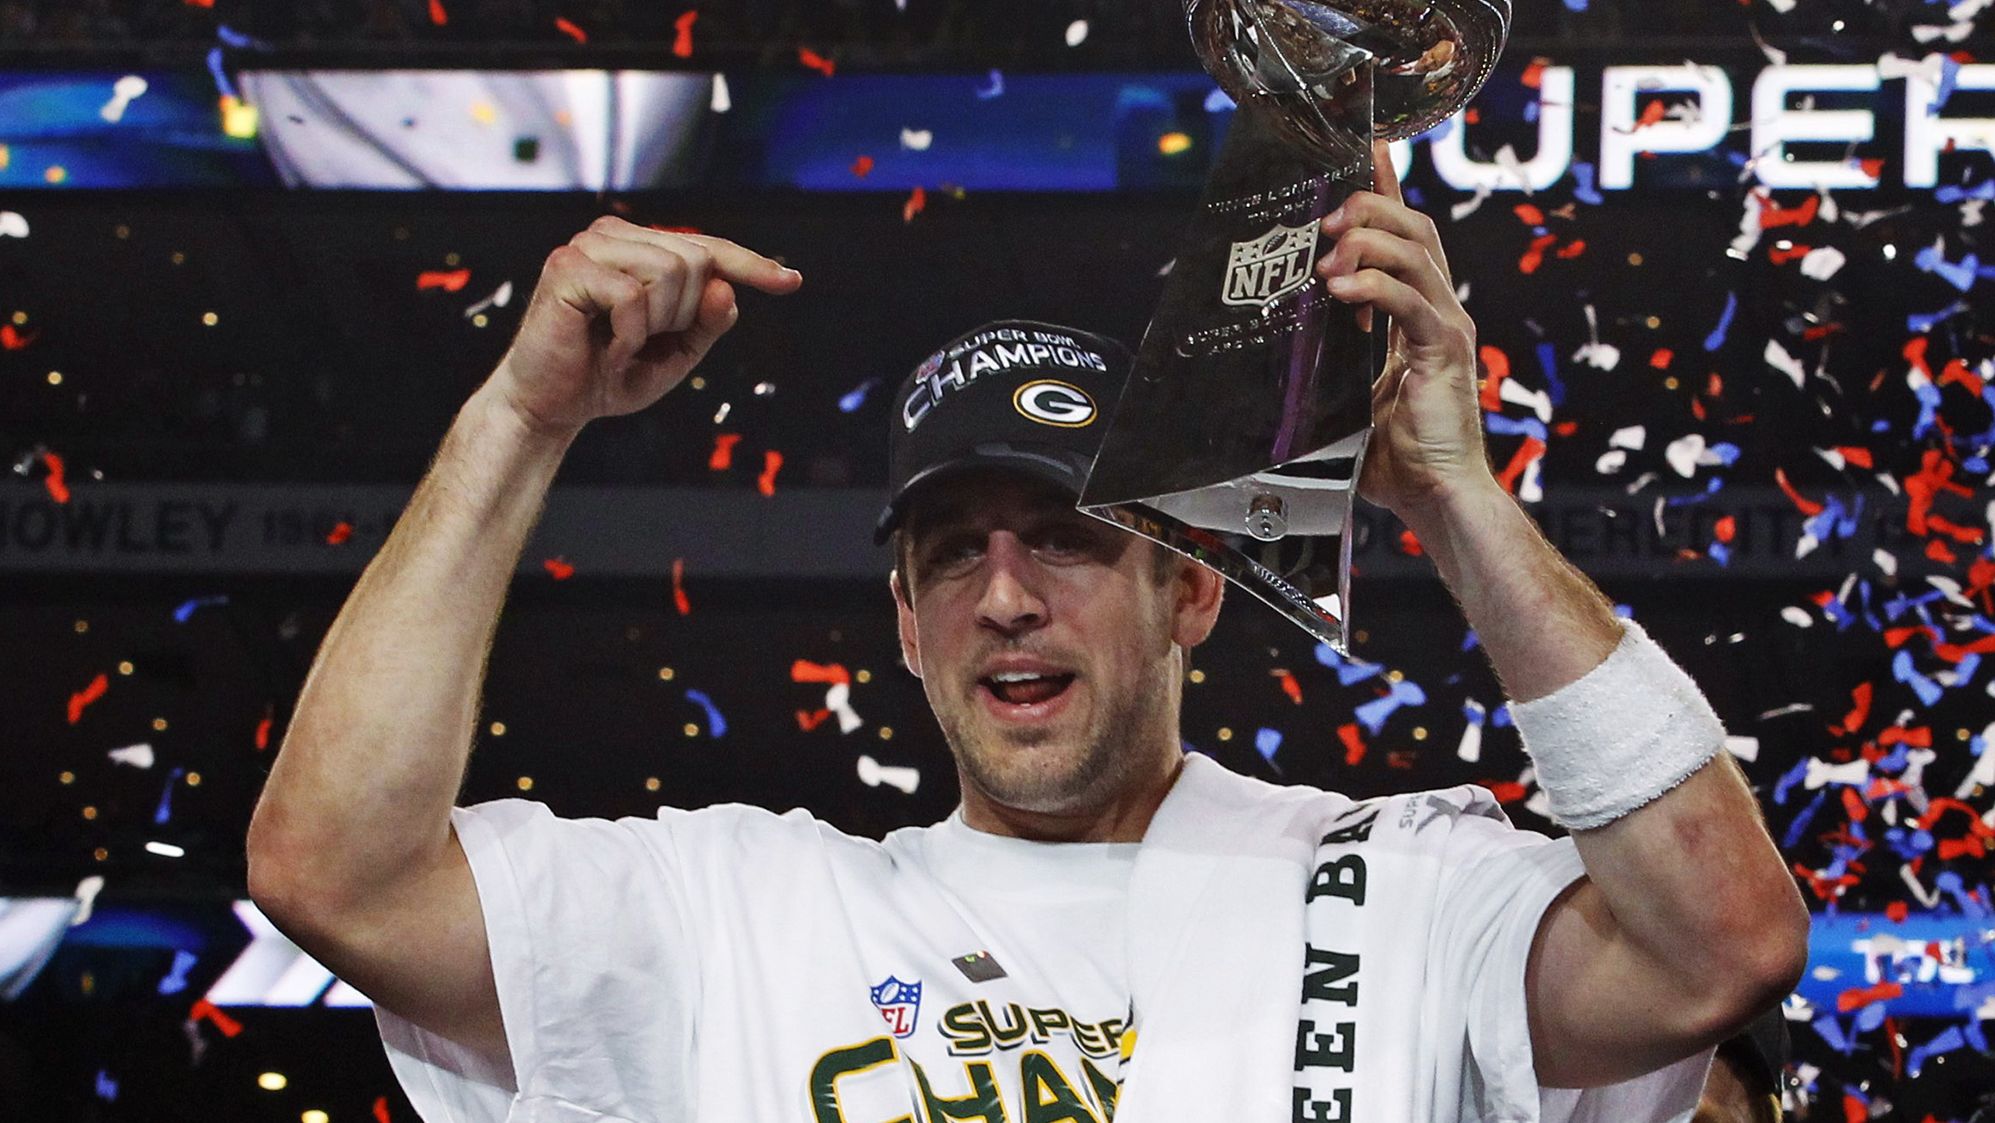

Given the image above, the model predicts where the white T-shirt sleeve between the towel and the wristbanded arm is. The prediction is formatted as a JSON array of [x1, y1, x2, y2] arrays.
[[1434, 816, 1712, 1123]]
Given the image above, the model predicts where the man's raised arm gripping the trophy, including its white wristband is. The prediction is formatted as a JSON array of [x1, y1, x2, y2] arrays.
[[1319, 146, 1807, 1087]]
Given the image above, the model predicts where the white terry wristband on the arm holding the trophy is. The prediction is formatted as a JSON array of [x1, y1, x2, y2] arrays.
[[1510, 618, 1726, 830]]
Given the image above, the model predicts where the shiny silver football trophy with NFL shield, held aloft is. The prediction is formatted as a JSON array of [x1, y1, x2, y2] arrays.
[[1081, 0, 1510, 654]]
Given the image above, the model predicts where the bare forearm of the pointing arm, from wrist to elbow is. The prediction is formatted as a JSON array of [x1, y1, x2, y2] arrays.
[[249, 389, 569, 909]]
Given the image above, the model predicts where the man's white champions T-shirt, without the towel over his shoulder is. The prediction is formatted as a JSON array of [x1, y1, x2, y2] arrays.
[[377, 769, 1704, 1123]]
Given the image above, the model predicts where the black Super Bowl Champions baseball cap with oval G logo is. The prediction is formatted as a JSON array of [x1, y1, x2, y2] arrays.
[[874, 319, 1129, 545]]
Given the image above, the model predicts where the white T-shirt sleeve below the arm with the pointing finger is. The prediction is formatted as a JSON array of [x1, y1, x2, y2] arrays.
[[375, 800, 698, 1123]]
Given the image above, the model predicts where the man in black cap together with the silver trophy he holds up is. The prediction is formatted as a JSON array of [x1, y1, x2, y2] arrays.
[[249, 0, 1807, 1123]]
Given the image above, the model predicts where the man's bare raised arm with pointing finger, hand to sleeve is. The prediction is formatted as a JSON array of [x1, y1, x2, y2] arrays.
[[249, 217, 802, 1057]]
